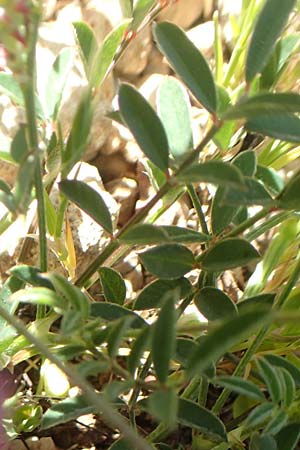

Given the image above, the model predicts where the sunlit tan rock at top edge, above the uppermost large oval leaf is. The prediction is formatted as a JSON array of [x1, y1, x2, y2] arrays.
[[158, 0, 213, 29]]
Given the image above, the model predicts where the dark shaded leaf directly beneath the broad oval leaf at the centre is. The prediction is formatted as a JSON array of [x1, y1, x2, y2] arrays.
[[134, 278, 192, 310]]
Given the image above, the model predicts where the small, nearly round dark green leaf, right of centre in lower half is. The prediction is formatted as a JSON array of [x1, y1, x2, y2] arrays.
[[194, 287, 237, 320]]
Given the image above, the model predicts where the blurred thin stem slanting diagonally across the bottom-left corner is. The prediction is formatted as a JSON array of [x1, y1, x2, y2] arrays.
[[0, 305, 153, 450]]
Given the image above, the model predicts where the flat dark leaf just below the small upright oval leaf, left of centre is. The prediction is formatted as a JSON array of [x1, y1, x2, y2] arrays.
[[91, 302, 147, 328]]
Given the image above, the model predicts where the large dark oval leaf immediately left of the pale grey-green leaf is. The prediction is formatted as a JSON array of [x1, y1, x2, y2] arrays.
[[119, 84, 169, 172]]
